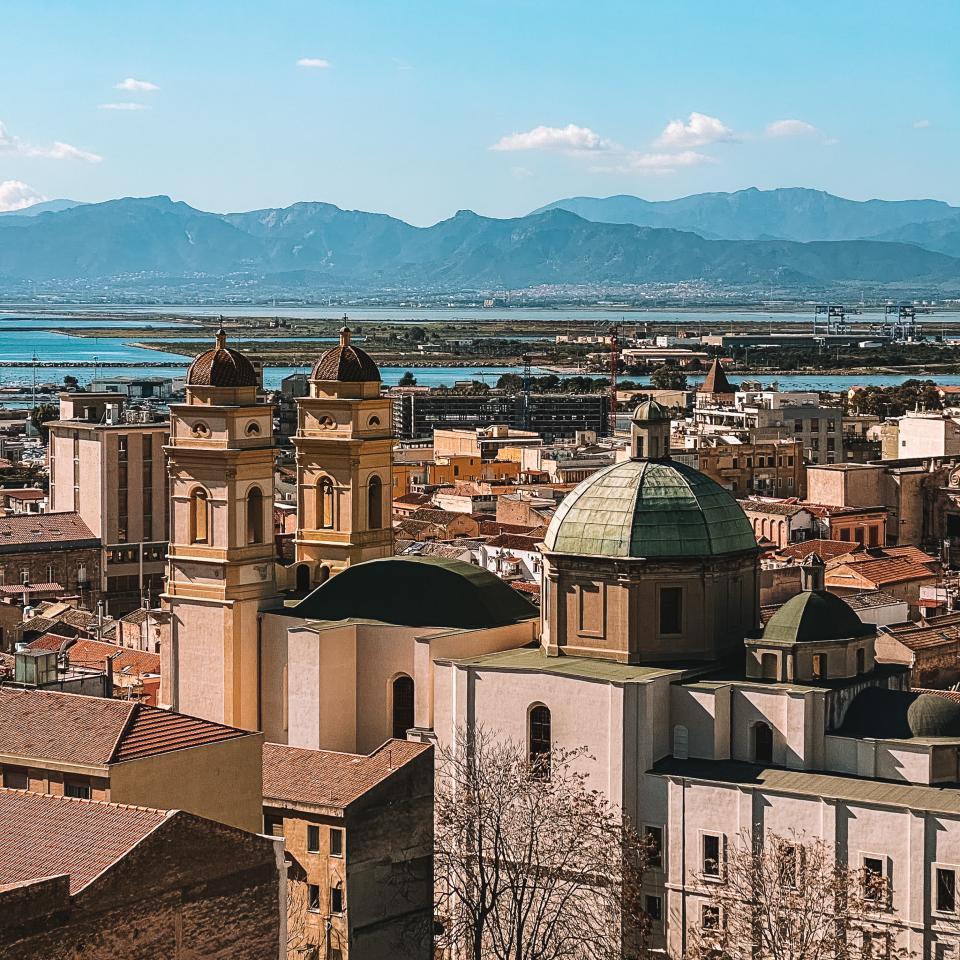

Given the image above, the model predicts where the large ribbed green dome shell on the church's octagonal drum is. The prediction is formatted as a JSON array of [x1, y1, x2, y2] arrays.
[[544, 460, 757, 559]]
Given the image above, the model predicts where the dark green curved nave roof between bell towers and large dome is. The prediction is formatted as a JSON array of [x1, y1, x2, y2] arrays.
[[288, 557, 538, 628]]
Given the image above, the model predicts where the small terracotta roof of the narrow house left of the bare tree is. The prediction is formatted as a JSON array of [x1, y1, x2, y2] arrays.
[[263, 740, 430, 807]]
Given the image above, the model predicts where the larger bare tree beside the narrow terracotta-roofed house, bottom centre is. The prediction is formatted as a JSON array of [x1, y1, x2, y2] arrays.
[[435, 730, 649, 960]]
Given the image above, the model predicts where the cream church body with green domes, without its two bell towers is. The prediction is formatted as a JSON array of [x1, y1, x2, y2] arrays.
[[172, 345, 960, 958]]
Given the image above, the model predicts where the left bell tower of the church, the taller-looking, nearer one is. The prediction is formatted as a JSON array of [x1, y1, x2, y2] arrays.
[[161, 324, 277, 730]]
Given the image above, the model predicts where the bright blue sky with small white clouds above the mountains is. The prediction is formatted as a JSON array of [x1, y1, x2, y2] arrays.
[[0, 0, 960, 225]]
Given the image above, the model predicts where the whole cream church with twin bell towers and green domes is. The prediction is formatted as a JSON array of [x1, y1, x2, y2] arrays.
[[162, 330, 960, 958]]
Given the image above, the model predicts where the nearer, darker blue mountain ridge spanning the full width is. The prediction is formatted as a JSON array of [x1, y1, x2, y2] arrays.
[[0, 189, 960, 294]]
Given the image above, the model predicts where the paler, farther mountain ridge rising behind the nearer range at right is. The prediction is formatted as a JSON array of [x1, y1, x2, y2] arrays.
[[534, 187, 960, 255]]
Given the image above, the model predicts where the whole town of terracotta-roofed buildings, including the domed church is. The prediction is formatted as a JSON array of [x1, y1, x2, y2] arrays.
[[0, 325, 960, 960]]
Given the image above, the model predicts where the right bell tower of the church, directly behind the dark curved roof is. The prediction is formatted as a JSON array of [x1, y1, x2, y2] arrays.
[[293, 318, 393, 590]]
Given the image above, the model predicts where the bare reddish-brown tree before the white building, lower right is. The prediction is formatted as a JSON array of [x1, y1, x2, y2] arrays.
[[687, 833, 910, 960]]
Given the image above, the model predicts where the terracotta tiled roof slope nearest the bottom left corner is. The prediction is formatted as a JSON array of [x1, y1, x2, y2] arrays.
[[0, 789, 168, 893]]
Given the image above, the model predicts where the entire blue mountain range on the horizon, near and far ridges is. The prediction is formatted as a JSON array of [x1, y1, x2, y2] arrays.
[[0, 190, 960, 295]]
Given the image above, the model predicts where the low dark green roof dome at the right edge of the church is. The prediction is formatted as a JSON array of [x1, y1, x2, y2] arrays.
[[841, 687, 960, 740]]
